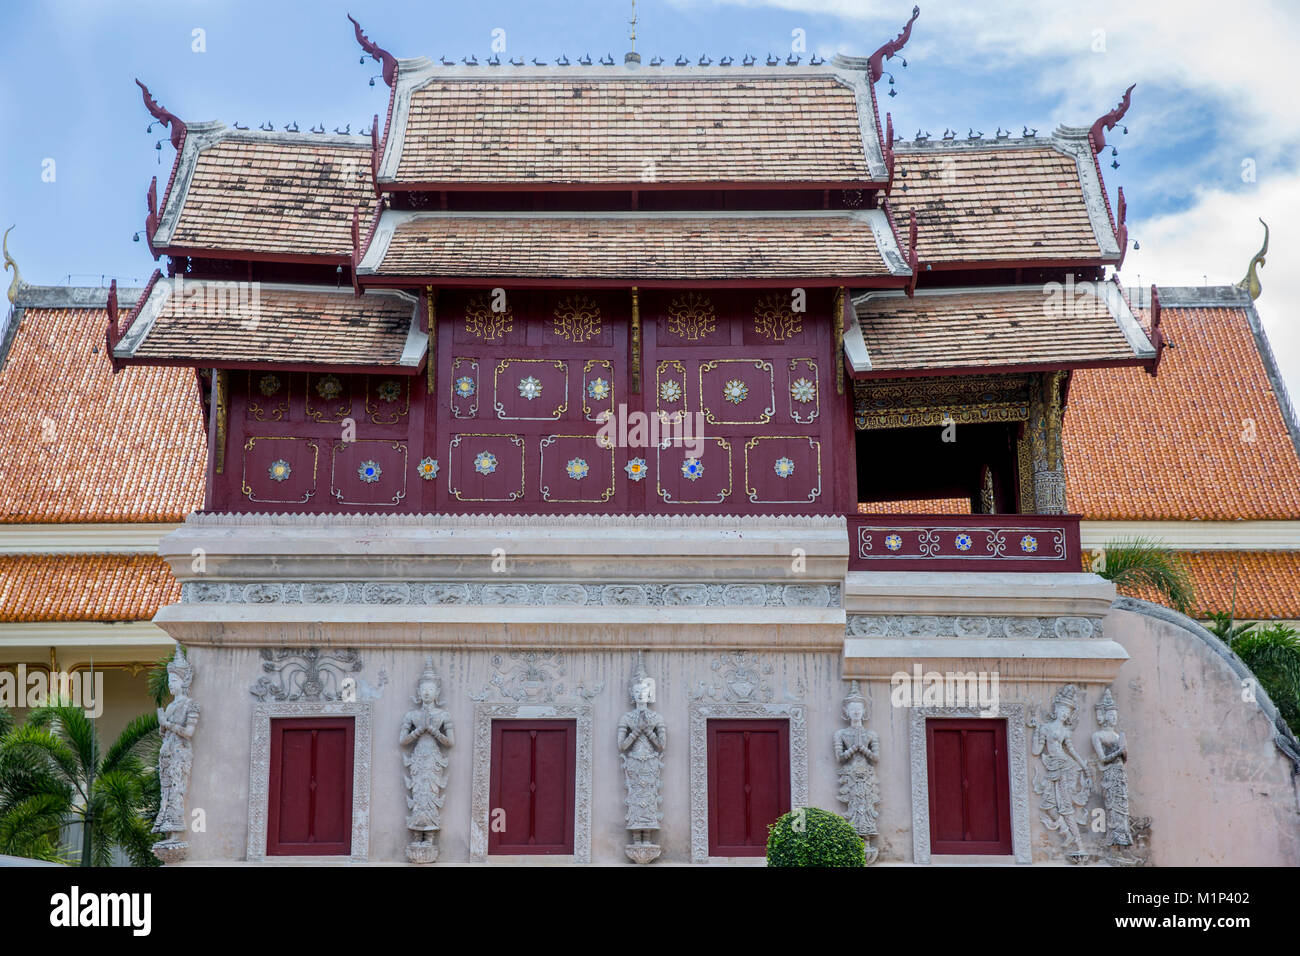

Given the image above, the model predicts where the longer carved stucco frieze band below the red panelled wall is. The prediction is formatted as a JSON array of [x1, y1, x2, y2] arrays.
[[181, 581, 840, 607]]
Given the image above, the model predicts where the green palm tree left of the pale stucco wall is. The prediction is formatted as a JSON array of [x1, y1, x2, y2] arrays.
[[0, 706, 159, 866]]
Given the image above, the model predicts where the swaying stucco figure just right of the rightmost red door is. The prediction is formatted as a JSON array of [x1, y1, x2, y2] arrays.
[[1028, 684, 1092, 862]]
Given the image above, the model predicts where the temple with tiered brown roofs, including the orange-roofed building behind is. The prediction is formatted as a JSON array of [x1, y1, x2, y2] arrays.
[[0, 12, 1300, 865]]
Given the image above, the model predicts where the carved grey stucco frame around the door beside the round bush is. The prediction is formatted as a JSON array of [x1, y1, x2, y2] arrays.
[[689, 650, 809, 864]]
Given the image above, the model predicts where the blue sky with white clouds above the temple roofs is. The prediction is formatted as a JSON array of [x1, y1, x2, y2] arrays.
[[0, 0, 1300, 394]]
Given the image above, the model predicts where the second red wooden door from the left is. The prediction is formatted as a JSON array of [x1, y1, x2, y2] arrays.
[[488, 721, 577, 853]]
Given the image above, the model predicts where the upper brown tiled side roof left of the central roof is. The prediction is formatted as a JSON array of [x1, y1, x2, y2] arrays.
[[153, 124, 377, 260]]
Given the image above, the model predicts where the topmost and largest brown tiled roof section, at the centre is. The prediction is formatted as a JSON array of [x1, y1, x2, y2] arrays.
[[393, 74, 874, 185]]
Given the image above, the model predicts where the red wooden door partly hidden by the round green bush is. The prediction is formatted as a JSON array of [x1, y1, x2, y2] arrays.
[[709, 721, 790, 856]]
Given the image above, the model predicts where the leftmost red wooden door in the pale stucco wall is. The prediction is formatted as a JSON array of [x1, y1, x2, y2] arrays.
[[267, 717, 354, 856]]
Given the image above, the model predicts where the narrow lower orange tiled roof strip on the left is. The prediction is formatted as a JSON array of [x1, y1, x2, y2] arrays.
[[0, 554, 181, 623]]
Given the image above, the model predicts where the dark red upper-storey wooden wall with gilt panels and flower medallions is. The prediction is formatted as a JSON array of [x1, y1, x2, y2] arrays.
[[209, 289, 855, 514]]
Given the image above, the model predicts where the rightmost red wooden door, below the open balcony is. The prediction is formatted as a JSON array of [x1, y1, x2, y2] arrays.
[[926, 719, 1011, 855]]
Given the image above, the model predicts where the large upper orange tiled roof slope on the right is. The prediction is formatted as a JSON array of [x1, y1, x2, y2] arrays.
[[1063, 306, 1300, 520]]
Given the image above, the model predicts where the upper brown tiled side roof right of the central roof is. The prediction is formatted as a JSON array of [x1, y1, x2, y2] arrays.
[[891, 127, 1119, 269]]
